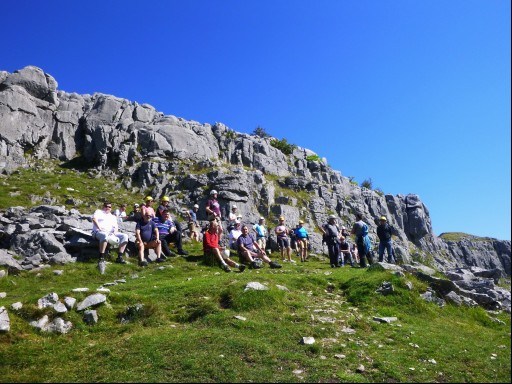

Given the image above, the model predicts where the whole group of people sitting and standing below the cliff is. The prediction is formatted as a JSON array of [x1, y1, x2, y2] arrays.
[[92, 190, 394, 272]]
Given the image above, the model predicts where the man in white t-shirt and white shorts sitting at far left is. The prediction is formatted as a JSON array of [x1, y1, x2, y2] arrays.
[[92, 201, 128, 264]]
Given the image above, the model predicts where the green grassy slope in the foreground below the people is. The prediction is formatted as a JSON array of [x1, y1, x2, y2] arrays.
[[0, 244, 511, 382]]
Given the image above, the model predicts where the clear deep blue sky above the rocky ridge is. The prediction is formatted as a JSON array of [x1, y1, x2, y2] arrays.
[[0, 0, 511, 240]]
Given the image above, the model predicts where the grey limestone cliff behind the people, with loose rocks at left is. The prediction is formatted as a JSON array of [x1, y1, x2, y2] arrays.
[[0, 66, 510, 275]]
